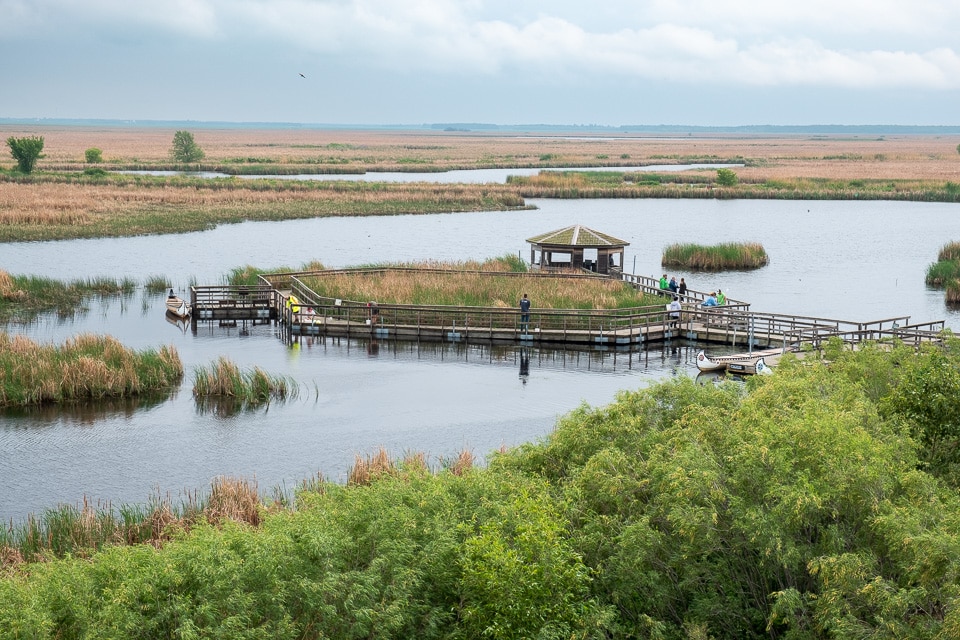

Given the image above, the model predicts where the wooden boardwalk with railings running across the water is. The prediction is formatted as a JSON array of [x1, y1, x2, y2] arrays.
[[191, 273, 944, 349]]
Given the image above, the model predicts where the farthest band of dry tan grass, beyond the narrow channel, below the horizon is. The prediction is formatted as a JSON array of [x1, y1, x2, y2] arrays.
[[0, 125, 960, 180]]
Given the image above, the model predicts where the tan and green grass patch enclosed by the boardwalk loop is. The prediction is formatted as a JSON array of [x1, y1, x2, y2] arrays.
[[302, 261, 660, 309]]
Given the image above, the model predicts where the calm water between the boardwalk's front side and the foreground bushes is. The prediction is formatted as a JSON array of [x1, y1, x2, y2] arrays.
[[0, 310, 696, 520]]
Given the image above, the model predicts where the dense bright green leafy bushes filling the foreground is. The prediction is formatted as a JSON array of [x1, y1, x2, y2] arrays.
[[0, 342, 960, 639]]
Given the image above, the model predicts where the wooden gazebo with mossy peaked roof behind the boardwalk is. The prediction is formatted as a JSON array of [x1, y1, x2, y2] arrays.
[[527, 224, 630, 273]]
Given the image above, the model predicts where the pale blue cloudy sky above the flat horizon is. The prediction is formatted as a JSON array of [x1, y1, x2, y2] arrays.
[[0, 0, 960, 126]]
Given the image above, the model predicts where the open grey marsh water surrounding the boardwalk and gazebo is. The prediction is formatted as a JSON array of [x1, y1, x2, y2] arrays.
[[0, 195, 960, 520]]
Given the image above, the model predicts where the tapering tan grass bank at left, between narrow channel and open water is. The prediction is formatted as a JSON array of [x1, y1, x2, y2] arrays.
[[0, 174, 525, 241]]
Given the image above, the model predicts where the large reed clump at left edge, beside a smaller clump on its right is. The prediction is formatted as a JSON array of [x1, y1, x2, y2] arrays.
[[0, 332, 183, 407]]
